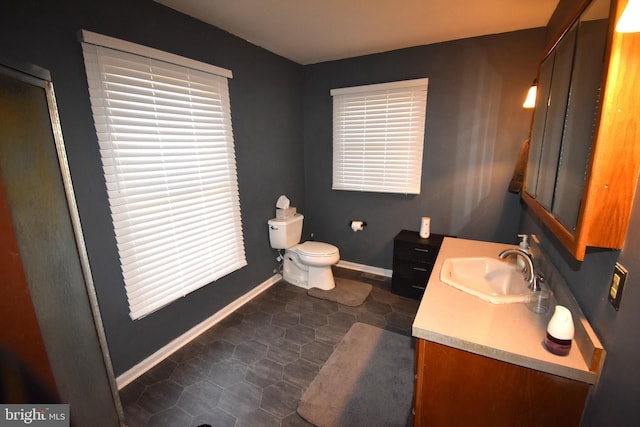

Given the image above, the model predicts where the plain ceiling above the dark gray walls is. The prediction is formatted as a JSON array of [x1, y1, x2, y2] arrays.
[[155, 0, 558, 65]]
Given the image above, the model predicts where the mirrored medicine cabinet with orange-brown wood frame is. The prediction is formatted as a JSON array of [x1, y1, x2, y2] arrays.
[[522, 0, 640, 260]]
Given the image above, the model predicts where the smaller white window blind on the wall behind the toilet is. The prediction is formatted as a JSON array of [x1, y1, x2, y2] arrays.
[[331, 78, 428, 194]]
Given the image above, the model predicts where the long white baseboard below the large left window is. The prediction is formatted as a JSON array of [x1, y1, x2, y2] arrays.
[[116, 274, 282, 390]]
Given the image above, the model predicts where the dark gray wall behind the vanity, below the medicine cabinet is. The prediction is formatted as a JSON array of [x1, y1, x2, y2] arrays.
[[521, 0, 640, 427]]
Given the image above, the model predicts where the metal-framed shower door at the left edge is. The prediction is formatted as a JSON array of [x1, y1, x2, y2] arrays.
[[0, 61, 122, 427]]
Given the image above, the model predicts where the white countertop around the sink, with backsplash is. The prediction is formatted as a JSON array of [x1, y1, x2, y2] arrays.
[[413, 238, 604, 384]]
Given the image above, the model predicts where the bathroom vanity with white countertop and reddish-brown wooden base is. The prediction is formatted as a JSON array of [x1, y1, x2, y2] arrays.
[[413, 238, 605, 427]]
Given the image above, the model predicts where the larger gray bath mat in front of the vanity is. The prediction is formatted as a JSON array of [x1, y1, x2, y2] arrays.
[[298, 323, 414, 427]]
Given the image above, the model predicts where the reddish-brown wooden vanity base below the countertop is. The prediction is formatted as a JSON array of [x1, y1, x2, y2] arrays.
[[413, 339, 589, 427]]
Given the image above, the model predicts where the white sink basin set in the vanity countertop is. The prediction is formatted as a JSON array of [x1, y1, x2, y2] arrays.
[[440, 257, 529, 304]]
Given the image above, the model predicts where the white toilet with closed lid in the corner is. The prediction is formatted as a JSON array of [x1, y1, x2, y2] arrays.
[[267, 214, 340, 290]]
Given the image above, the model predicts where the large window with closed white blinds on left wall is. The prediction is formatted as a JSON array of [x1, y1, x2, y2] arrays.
[[82, 31, 247, 319]]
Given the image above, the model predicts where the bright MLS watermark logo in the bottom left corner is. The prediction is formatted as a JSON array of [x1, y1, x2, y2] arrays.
[[0, 404, 69, 427]]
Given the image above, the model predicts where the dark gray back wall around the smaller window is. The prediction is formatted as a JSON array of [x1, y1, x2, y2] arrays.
[[304, 29, 545, 269]]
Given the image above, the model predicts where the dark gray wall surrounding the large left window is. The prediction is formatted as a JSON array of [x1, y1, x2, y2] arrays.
[[0, 0, 304, 375]]
